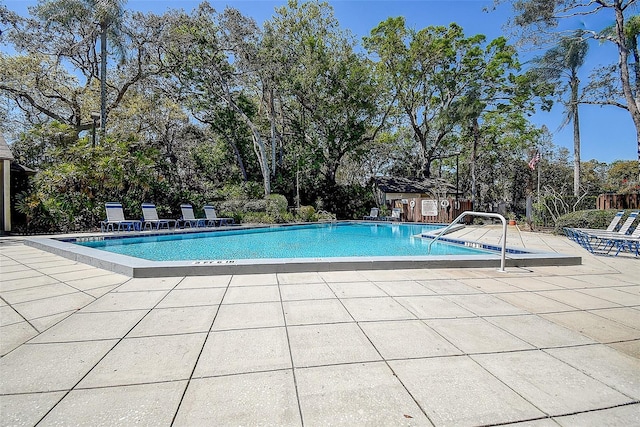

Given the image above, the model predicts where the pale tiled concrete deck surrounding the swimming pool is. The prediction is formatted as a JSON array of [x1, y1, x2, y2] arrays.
[[0, 226, 640, 426]]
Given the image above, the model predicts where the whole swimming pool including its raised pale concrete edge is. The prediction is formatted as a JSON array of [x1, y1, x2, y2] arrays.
[[25, 221, 581, 277]]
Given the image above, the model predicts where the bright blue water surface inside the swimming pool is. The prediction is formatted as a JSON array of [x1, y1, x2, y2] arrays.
[[76, 223, 487, 261]]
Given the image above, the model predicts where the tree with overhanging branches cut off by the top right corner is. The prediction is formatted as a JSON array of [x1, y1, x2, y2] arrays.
[[494, 0, 640, 176]]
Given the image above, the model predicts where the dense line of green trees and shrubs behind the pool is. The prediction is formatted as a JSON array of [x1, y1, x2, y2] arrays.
[[0, 0, 637, 230]]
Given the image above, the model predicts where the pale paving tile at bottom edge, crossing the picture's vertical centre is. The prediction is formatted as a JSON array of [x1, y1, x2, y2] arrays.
[[296, 363, 432, 426]]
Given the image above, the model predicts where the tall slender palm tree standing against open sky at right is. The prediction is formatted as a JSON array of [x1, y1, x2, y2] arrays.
[[533, 30, 589, 196]]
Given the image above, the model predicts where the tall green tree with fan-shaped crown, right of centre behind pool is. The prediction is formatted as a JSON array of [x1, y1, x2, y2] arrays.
[[364, 17, 523, 177]]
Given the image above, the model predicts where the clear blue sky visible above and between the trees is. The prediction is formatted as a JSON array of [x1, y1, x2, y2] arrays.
[[0, 0, 637, 163]]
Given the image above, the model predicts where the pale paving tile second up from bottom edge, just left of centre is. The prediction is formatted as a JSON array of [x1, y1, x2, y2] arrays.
[[194, 328, 291, 377]]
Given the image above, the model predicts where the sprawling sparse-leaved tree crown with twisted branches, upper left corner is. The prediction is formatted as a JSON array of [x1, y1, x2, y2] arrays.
[[0, 0, 166, 133]]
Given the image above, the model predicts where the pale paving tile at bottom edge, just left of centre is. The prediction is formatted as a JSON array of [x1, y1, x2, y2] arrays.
[[175, 370, 302, 426]]
